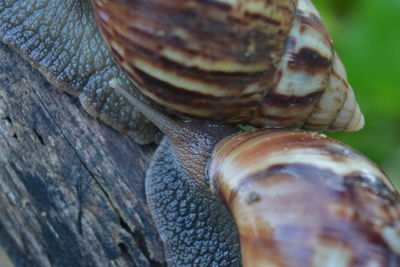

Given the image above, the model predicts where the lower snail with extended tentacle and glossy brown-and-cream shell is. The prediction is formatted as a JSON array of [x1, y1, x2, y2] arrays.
[[112, 81, 400, 267]]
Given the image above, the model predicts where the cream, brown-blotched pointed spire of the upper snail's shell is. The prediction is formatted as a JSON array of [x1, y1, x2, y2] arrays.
[[250, 0, 364, 131]]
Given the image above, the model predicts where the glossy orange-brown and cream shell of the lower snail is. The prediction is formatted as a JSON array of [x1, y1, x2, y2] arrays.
[[209, 131, 400, 267]]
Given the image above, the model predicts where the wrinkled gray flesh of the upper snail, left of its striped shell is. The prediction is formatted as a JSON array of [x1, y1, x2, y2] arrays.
[[0, 0, 157, 144]]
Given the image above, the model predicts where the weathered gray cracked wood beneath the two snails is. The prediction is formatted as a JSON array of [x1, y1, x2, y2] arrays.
[[0, 42, 165, 266]]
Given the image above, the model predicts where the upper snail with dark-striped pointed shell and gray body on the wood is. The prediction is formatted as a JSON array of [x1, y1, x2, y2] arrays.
[[0, 0, 364, 144]]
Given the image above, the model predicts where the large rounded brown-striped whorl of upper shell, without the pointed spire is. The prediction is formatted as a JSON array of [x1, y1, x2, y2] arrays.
[[93, 0, 295, 122]]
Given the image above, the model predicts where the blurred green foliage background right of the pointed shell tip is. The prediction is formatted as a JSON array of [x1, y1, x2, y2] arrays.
[[313, 0, 400, 188]]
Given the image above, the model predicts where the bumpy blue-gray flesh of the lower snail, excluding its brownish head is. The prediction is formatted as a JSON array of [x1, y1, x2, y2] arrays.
[[146, 138, 241, 266]]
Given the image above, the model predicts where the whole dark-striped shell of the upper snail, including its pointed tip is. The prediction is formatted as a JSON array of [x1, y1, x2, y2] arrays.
[[92, 0, 364, 131]]
